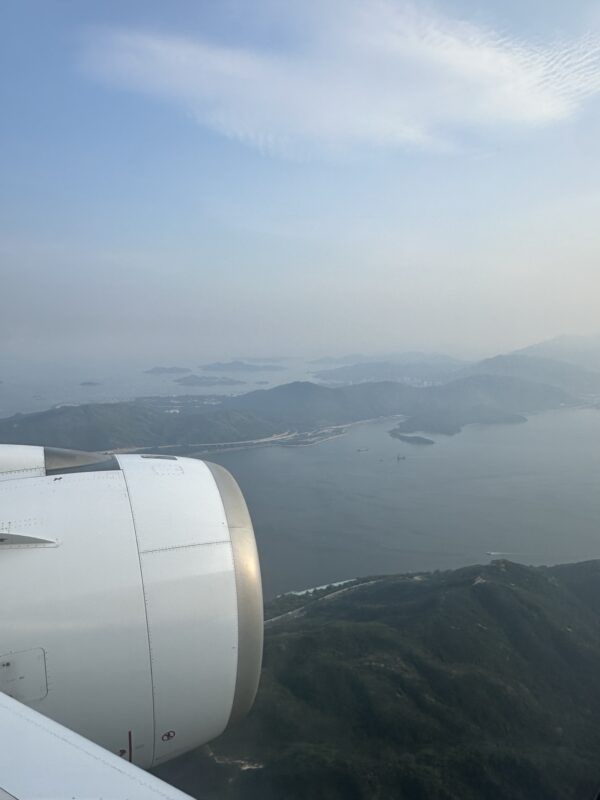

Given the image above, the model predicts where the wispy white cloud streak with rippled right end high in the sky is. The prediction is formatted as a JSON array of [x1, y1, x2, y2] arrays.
[[85, 0, 600, 155]]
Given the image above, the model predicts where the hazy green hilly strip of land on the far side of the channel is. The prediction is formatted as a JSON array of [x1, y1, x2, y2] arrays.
[[0, 375, 573, 450]]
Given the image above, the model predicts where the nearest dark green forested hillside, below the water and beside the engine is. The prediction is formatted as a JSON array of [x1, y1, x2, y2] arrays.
[[160, 561, 600, 800]]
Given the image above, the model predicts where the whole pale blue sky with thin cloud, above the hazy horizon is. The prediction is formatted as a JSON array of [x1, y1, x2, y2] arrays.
[[0, 0, 600, 365]]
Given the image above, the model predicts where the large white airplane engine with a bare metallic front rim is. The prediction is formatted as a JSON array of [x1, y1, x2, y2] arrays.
[[0, 445, 263, 768]]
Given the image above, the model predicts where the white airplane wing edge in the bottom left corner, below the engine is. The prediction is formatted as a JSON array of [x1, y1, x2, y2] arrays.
[[0, 692, 191, 800]]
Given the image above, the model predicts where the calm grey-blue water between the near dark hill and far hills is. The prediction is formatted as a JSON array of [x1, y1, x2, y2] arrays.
[[211, 409, 600, 597]]
